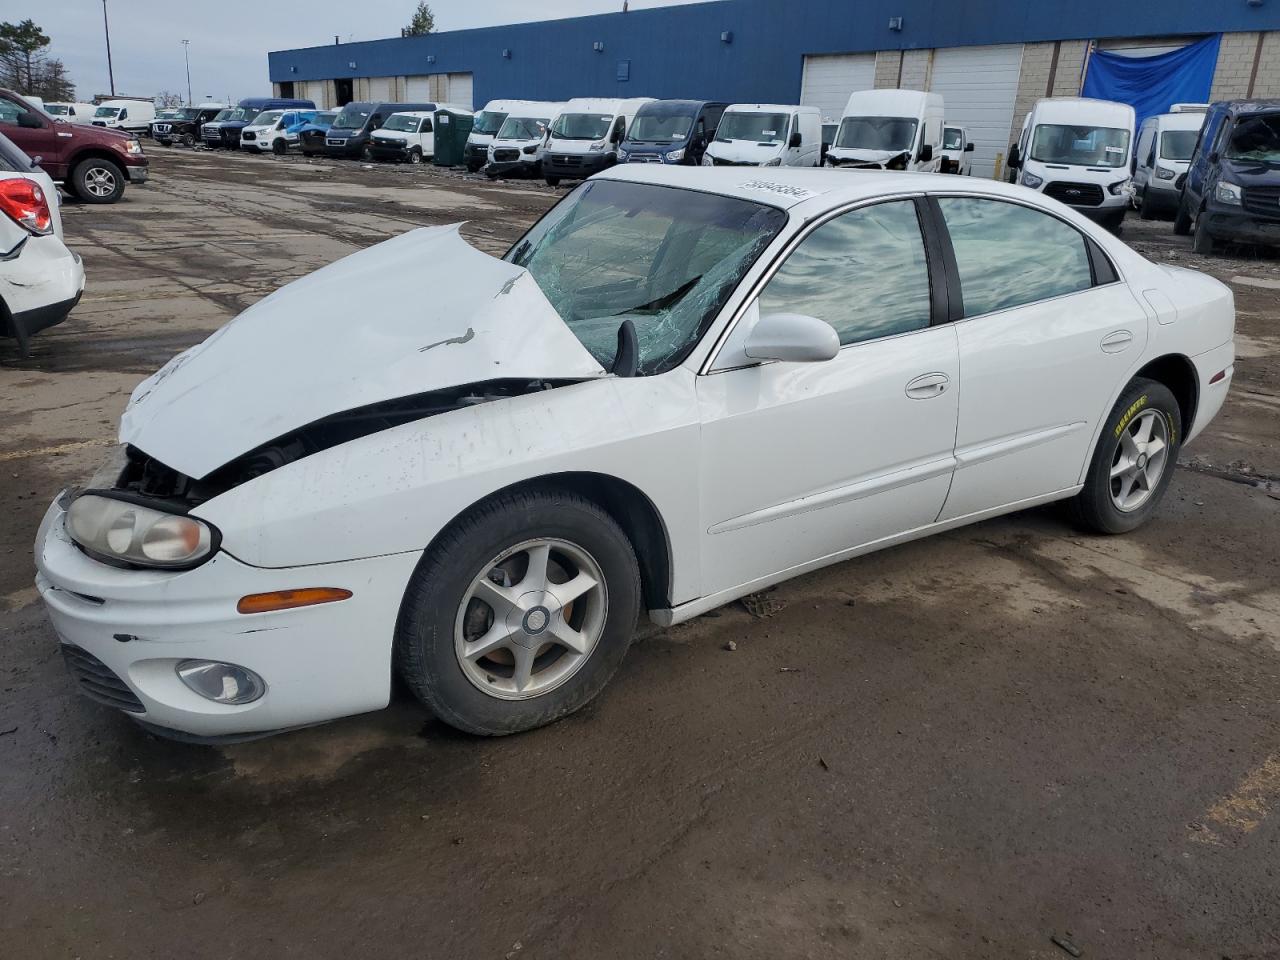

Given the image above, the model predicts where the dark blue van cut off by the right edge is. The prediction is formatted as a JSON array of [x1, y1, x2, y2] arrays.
[[1174, 100, 1280, 253]]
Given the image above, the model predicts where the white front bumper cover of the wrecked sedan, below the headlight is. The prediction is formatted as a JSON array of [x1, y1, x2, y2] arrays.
[[36, 494, 419, 737]]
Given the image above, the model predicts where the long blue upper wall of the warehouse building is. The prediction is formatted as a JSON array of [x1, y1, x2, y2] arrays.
[[268, 0, 1280, 106]]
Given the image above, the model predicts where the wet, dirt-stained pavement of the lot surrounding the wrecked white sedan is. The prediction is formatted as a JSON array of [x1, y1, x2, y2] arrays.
[[0, 148, 1280, 960]]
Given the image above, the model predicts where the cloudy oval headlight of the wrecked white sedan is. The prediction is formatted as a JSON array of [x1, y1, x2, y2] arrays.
[[67, 494, 218, 568]]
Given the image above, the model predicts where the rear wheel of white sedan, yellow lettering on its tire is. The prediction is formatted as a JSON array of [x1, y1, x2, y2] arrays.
[[1071, 378, 1183, 534]]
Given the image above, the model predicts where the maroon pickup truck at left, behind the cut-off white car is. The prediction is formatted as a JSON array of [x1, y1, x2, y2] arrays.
[[0, 90, 147, 204]]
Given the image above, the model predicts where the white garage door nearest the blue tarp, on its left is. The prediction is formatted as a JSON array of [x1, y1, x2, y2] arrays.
[[932, 44, 1023, 177]]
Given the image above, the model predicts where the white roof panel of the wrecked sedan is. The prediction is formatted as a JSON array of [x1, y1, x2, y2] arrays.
[[593, 164, 1039, 212]]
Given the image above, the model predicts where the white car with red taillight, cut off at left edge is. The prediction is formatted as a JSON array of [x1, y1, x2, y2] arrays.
[[0, 134, 84, 353]]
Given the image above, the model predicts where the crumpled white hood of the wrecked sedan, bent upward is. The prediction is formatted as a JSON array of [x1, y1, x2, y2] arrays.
[[120, 224, 604, 477]]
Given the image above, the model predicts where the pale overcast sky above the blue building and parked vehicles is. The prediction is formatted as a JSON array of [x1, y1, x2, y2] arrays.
[[10, 0, 690, 100]]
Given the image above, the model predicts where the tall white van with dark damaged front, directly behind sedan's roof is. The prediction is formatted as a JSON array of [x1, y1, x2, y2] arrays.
[[827, 90, 946, 173]]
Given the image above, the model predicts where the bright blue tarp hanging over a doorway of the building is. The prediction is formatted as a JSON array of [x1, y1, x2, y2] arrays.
[[1084, 33, 1222, 127]]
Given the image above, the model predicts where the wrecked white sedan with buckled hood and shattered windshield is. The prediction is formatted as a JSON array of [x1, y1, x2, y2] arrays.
[[36, 165, 1235, 739]]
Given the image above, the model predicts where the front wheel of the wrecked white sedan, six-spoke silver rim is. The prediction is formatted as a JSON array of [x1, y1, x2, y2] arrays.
[[396, 489, 640, 736]]
